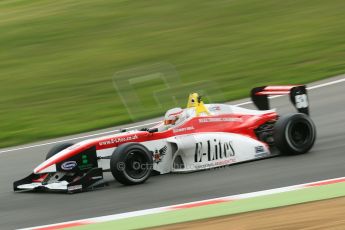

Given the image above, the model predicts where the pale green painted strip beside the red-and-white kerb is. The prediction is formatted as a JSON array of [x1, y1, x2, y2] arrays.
[[68, 183, 345, 230]]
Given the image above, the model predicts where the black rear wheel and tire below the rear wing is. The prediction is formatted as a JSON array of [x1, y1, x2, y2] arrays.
[[273, 113, 316, 155]]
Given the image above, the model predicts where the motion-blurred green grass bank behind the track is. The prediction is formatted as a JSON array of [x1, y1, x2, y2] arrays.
[[0, 0, 345, 147]]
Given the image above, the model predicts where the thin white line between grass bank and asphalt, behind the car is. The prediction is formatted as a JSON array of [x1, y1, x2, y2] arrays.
[[0, 78, 345, 155]]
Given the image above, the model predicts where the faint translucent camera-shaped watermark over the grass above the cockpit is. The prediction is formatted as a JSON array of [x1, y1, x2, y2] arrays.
[[113, 63, 225, 121]]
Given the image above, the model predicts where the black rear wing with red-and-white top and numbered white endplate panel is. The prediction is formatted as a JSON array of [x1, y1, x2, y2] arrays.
[[251, 85, 309, 115]]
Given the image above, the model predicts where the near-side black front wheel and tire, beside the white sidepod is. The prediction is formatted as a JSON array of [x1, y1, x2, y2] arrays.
[[110, 143, 153, 185]]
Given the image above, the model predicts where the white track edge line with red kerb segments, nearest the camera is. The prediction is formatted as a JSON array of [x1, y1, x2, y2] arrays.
[[20, 177, 345, 230]]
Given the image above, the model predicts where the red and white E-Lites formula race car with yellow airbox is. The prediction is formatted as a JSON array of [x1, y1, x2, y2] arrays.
[[13, 85, 316, 193]]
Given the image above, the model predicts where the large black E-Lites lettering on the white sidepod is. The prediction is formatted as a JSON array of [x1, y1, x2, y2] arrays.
[[194, 139, 235, 162]]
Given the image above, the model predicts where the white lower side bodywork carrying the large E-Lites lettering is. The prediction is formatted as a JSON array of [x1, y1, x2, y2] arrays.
[[97, 132, 271, 174]]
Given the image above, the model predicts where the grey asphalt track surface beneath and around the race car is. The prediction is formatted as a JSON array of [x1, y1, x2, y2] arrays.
[[0, 75, 345, 229]]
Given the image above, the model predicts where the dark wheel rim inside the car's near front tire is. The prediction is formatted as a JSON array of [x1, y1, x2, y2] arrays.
[[124, 150, 150, 180]]
